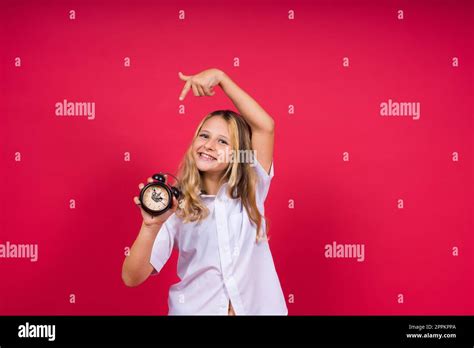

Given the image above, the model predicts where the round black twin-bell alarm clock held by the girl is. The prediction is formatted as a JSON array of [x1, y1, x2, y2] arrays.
[[140, 173, 181, 216]]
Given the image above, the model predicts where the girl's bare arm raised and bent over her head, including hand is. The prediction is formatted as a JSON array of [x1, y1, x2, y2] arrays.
[[179, 69, 275, 172]]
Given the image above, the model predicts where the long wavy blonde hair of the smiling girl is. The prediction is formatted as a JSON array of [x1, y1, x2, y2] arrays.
[[176, 110, 262, 240]]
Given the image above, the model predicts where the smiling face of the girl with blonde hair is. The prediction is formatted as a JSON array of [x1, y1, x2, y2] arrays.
[[192, 116, 232, 173]]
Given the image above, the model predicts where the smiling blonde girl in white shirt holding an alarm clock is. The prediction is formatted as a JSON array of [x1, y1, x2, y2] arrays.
[[122, 69, 288, 315]]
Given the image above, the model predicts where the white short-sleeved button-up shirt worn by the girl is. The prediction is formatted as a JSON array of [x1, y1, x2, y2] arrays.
[[150, 161, 288, 315]]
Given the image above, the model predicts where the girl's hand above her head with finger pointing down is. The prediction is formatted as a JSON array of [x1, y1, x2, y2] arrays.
[[178, 69, 224, 100]]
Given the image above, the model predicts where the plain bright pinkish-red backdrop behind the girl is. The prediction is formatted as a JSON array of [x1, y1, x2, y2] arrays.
[[0, 1, 474, 315]]
